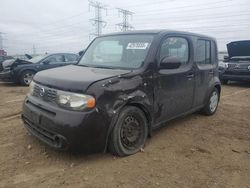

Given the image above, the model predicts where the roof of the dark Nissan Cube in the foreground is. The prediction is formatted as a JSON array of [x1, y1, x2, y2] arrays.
[[100, 29, 216, 40]]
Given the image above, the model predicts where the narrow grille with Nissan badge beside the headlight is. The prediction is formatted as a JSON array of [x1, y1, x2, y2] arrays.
[[33, 84, 57, 102]]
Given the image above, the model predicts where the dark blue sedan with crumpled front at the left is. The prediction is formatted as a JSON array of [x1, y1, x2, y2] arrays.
[[0, 53, 79, 85]]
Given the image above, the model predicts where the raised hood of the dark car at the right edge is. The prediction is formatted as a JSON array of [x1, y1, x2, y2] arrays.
[[227, 40, 250, 57]]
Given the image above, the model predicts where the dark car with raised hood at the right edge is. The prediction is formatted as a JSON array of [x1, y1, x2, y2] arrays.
[[219, 40, 250, 84]]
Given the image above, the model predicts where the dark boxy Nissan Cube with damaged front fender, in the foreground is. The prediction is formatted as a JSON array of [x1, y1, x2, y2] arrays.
[[22, 30, 221, 156]]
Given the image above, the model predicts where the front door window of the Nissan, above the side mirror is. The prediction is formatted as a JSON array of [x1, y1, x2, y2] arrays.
[[160, 37, 189, 65]]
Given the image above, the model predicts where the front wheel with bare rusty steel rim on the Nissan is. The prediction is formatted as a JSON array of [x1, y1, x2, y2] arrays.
[[108, 106, 148, 157]]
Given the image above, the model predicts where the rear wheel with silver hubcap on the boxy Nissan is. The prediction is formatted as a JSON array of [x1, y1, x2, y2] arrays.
[[202, 88, 220, 116]]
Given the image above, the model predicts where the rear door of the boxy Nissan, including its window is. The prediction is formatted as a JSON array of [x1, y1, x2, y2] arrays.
[[194, 39, 217, 107]]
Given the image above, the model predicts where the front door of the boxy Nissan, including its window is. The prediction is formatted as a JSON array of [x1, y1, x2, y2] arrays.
[[154, 36, 195, 125]]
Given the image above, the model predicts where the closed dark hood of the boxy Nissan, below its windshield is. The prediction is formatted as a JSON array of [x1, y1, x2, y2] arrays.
[[34, 65, 131, 92]]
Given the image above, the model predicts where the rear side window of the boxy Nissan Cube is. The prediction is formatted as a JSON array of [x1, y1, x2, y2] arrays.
[[196, 40, 212, 65]]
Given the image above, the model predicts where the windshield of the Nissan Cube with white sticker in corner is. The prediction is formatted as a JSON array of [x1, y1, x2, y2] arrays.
[[78, 34, 153, 69]]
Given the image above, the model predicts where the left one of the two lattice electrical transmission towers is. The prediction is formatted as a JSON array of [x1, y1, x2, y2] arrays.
[[89, 0, 107, 36]]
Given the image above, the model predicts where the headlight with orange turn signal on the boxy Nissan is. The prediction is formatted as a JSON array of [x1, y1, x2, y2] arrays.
[[56, 90, 95, 110]]
